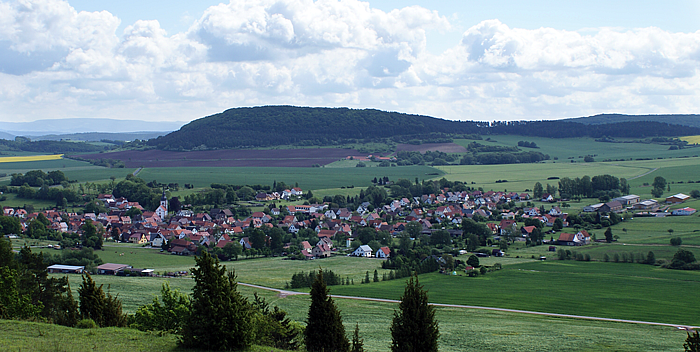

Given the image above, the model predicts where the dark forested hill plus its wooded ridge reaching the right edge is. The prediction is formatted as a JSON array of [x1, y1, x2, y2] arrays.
[[148, 106, 700, 150]]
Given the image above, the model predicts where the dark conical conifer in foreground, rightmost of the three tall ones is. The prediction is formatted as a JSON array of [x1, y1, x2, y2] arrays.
[[390, 275, 440, 352]]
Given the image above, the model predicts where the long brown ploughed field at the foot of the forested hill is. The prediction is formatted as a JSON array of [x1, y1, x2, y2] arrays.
[[80, 148, 361, 168]]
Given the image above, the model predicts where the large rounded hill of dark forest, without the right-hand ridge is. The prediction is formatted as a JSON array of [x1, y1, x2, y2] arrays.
[[149, 106, 479, 150]]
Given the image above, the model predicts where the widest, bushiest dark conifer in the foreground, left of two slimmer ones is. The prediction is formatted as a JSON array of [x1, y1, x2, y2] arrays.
[[180, 251, 254, 351]]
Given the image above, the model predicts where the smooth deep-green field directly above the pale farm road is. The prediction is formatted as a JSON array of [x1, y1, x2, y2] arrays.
[[334, 261, 700, 325]]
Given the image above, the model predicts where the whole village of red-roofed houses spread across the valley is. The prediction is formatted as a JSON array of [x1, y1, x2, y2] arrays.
[[3, 179, 696, 275]]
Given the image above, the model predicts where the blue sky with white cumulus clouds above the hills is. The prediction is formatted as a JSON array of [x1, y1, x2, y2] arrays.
[[0, 0, 700, 123]]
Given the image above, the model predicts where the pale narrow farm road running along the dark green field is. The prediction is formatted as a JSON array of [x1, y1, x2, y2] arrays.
[[238, 282, 700, 330]]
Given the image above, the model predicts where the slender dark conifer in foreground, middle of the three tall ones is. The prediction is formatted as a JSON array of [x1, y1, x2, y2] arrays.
[[304, 269, 350, 352]]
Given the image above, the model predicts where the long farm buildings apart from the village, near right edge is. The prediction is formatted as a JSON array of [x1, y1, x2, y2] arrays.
[[583, 193, 695, 217]]
